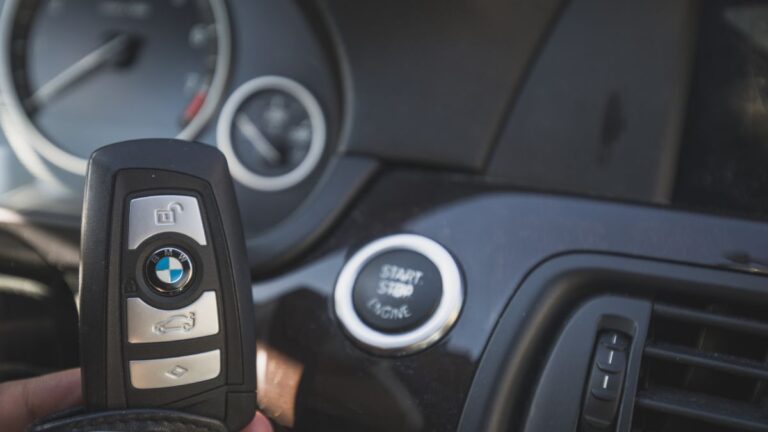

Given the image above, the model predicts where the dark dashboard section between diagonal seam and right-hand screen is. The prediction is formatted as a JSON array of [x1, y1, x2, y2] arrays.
[[488, 0, 696, 203]]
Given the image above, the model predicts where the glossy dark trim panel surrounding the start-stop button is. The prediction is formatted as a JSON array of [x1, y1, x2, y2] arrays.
[[249, 172, 768, 430]]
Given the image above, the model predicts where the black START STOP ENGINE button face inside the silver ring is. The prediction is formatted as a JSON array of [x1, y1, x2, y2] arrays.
[[352, 250, 443, 333]]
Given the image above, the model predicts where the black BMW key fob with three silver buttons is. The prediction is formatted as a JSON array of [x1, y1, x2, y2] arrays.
[[80, 139, 256, 430]]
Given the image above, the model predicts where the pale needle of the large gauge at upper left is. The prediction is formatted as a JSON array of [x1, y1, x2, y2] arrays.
[[26, 34, 131, 110]]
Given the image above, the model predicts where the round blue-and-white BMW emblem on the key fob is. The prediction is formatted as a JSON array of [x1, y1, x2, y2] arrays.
[[145, 247, 193, 294]]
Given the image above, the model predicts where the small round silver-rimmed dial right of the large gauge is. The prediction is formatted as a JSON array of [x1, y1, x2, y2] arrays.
[[217, 76, 325, 191]]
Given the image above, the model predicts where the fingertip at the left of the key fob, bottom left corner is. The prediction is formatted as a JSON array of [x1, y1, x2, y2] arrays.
[[0, 369, 83, 432]]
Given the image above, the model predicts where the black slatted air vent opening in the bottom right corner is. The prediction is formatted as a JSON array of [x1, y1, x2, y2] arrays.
[[632, 304, 768, 432]]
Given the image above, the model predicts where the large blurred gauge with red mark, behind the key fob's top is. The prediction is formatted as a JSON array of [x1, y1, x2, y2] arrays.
[[0, 0, 231, 174]]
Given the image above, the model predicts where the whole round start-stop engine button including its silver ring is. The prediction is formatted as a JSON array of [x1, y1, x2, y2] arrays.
[[334, 234, 464, 355]]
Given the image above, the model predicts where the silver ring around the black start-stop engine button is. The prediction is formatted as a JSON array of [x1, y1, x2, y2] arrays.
[[334, 234, 464, 354]]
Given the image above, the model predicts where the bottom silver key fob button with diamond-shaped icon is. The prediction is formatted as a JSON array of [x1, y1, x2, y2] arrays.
[[128, 350, 221, 390]]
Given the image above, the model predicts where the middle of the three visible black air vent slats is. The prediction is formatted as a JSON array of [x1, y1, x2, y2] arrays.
[[644, 343, 768, 380]]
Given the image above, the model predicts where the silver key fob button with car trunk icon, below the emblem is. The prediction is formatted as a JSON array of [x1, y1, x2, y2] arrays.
[[126, 291, 219, 343]]
